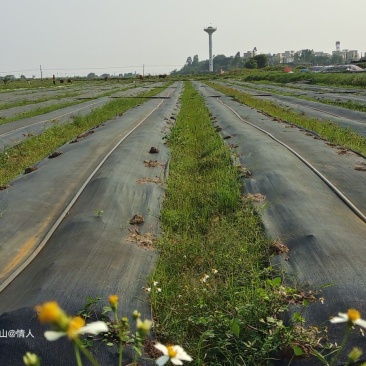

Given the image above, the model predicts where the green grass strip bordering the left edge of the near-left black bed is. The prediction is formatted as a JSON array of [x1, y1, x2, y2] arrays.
[[0, 84, 169, 185]]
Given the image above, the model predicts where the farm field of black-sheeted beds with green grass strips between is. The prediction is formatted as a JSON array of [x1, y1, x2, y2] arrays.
[[0, 79, 366, 365]]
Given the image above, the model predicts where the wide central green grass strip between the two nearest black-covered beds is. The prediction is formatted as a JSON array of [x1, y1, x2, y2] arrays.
[[150, 82, 300, 366]]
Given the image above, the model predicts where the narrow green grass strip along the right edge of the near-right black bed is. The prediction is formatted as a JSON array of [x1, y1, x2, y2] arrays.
[[206, 82, 366, 155]]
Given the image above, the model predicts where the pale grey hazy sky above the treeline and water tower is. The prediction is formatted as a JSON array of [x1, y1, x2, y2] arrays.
[[0, 0, 366, 77]]
